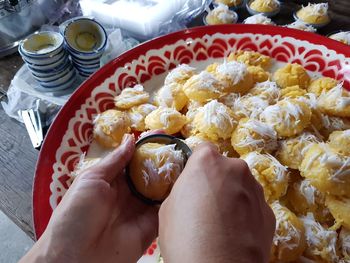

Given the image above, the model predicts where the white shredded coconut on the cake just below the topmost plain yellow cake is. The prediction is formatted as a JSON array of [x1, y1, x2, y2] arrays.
[[216, 60, 248, 85]]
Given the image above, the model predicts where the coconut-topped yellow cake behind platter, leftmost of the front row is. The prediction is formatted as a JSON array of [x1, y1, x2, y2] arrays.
[[206, 3, 237, 25]]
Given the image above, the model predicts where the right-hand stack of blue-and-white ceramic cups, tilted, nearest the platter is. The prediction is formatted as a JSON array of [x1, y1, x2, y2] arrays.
[[63, 17, 107, 77]]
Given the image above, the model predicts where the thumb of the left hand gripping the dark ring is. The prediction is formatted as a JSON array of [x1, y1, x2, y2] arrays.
[[81, 134, 135, 183]]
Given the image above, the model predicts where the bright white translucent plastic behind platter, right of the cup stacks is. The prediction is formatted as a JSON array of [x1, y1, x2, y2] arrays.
[[80, 0, 211, 41]]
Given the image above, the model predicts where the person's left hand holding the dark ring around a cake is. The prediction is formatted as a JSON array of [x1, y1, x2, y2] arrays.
[[22, 135, 158, 263]]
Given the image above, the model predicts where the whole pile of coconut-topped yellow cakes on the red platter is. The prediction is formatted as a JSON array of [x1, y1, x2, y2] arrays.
[[78, 51, 350, 262]]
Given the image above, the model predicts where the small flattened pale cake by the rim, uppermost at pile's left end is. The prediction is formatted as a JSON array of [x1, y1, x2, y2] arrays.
[[114, 85, 149, 110]]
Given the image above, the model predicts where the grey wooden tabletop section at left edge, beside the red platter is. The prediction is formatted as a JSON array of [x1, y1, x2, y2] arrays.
[[0, 108, 38, 239]]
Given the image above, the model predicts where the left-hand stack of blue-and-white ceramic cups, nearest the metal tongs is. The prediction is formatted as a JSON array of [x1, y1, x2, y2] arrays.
[[18, 32, 77, 91]]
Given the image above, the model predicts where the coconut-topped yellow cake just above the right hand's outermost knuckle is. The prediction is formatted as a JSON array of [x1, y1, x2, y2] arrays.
[[231, 118, 278, 156]]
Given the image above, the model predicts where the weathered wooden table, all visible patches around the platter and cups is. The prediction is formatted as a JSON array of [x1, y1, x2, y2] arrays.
[[0, 0, 350, 241]]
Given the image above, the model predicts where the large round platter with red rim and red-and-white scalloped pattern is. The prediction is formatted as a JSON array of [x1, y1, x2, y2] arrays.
[[33, 25, 350, 262]]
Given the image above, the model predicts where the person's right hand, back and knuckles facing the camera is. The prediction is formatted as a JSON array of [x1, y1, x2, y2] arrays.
[[159, 144, 275, 263]]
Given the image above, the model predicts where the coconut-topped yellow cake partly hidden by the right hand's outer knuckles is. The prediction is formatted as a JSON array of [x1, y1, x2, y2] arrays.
[[241, 152, 289, 202]]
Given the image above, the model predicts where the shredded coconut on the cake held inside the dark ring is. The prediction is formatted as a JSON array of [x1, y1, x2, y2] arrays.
[[142, 144, 185, 186]]
